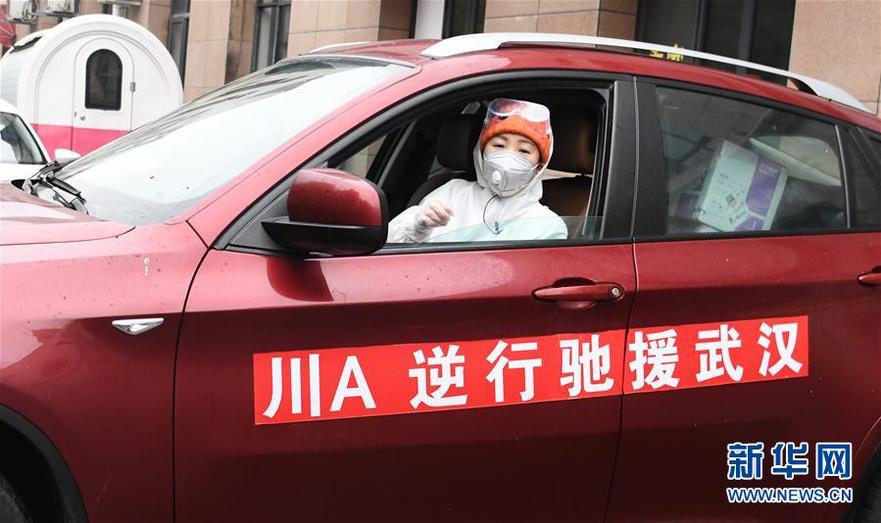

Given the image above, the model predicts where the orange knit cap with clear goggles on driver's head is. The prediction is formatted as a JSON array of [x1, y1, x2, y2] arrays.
[[477, 98, 554, 165]]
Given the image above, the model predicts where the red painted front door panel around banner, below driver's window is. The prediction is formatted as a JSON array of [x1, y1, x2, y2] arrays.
[[175, 245, 635, 521]]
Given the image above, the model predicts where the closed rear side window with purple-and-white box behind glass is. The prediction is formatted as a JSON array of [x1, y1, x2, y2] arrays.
[[657, 88, 847, 235]]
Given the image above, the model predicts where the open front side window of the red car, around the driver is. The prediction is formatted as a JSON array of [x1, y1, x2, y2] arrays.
[[218, 78, 635, 258]]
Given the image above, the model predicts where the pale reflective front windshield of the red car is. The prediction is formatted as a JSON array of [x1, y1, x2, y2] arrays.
[[58, 57, 407, 225]]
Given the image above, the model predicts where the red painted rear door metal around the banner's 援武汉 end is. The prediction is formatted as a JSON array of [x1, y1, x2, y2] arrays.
[[609, 233, 881, 521]]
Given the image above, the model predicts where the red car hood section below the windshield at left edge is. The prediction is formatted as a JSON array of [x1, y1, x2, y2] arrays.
[[0, 183, 133, 245]]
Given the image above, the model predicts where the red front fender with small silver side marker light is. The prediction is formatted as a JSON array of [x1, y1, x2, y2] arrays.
[[0, 212, 205, 521]]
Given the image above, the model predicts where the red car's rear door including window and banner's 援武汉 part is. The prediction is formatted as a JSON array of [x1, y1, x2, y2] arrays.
[[609, 84, 881, 521]]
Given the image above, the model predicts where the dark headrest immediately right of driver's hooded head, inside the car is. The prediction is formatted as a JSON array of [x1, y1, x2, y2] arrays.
[[548, 105, 596, 174]]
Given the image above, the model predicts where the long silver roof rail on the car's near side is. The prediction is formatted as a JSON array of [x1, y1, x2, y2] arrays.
[[422, 33, 870, 112]]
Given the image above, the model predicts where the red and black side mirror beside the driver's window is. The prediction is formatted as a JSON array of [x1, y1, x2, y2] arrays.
[[262, 169, 388, 256]]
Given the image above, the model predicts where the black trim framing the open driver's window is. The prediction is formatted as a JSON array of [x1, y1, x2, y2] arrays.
[[213, 69, 637, 259]]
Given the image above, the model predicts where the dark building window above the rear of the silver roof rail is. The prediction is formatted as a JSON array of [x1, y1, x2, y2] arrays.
[[636, 0, 795, 83]]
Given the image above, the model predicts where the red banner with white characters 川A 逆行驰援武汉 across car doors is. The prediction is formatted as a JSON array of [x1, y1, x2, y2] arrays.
[[253, 316, 808, 425]]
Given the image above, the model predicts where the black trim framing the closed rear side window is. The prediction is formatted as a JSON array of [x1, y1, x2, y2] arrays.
[[633, 76, 877, 243]]
